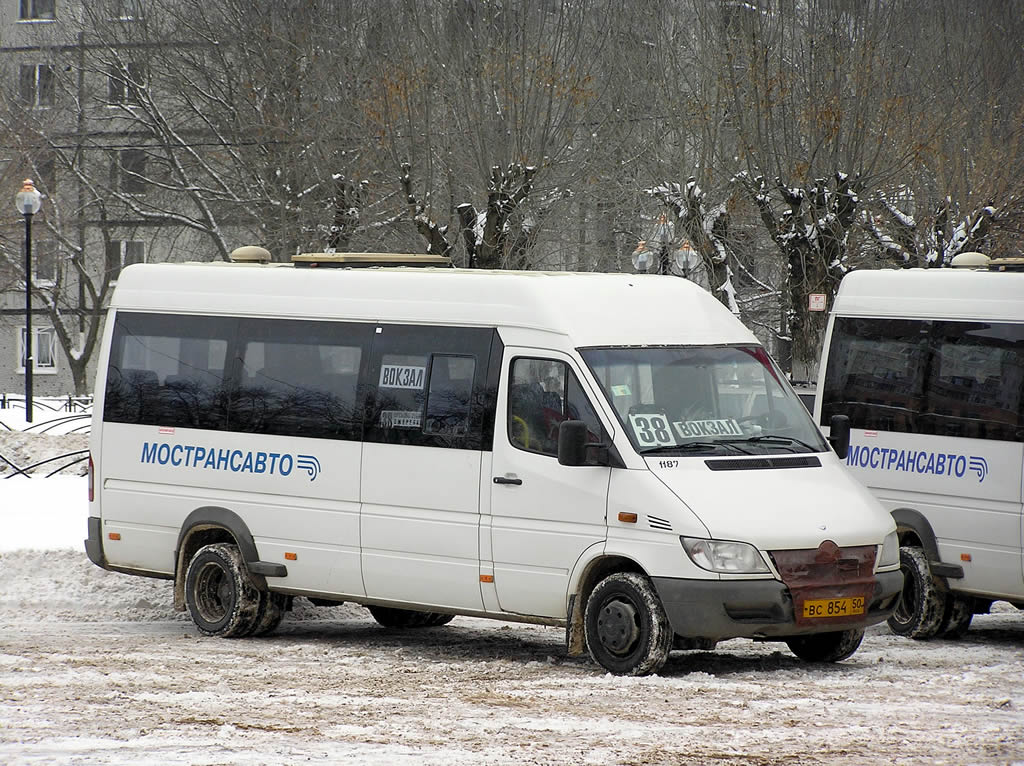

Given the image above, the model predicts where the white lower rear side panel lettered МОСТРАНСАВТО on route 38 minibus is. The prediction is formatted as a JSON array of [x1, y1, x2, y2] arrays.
[[99, 423, 364, 595]]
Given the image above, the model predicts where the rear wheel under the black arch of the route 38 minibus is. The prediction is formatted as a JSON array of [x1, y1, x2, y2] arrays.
[[185, 543, 261, 638]]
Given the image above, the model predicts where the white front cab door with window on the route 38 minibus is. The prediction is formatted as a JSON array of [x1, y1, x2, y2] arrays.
[[490, 348, 611, 618]]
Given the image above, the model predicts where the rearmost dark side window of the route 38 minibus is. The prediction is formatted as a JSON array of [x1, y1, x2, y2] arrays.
[[103, 312, 238, 429]]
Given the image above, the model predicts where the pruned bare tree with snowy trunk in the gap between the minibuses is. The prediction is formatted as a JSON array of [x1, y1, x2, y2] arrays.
[[704, 0, 950, 376]]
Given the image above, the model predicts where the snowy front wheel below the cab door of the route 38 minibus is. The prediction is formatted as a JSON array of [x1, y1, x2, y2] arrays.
[[584, 572, 673, 676]]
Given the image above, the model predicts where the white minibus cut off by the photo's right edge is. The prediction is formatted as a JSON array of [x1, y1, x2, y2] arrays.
[[815, 254, 1024, 639]]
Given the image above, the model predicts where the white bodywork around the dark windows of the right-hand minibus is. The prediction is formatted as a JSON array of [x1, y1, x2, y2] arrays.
[[814, 268, 1024, 601]]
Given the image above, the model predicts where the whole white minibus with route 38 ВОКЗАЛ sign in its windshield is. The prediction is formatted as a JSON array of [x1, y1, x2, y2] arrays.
[[86, 249, 902, 675]]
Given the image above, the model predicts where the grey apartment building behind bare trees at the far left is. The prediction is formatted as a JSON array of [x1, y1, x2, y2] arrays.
[[0, 0, 252, 396]]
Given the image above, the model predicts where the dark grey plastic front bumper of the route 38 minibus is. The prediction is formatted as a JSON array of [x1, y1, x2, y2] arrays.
[[651, 570, 903, 641]]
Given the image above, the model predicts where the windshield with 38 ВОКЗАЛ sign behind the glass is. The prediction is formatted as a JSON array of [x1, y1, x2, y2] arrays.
[[580, 346, 828, 457]]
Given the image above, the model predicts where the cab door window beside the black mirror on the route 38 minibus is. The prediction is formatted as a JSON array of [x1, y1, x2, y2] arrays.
[[508, 356, 604, 457]]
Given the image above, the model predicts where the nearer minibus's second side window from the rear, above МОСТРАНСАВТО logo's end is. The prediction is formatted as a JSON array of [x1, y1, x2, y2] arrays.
[[229, 320, 373, 439]]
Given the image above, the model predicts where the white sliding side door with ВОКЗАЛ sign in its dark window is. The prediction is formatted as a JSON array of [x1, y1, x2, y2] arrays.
[[360, 325, 500, 610]]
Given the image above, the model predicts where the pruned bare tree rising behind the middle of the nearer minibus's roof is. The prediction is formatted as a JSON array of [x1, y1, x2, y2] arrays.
[[367, 0, 608, 268]]
